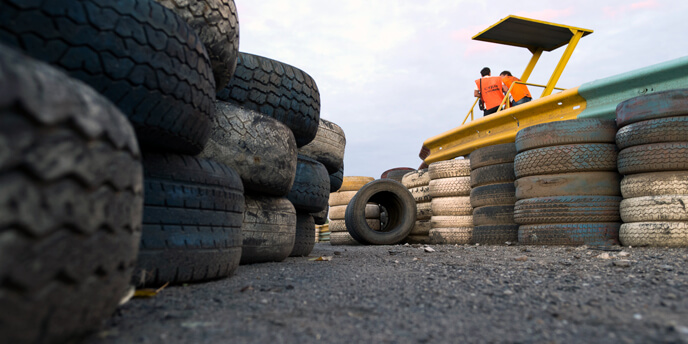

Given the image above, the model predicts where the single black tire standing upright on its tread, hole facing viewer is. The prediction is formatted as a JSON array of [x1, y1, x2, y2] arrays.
[[346, 179, 417, 245]]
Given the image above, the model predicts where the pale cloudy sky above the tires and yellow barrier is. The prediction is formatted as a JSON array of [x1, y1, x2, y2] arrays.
[[235, 0, 688, 178]]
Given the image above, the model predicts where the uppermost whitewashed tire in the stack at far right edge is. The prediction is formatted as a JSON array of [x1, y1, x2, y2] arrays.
[[621, 171, 688, 198]]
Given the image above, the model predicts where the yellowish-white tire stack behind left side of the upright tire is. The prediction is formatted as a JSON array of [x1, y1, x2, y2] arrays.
[[329, 176, 380, 245]]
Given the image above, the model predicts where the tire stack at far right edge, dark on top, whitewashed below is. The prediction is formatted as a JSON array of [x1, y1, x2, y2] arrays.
[[616, 89, 688, 247]]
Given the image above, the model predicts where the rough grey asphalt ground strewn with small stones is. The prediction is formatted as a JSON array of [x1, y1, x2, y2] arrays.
[[84, 243, 688, 344]]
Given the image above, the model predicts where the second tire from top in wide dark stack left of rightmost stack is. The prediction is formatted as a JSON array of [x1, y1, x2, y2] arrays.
[[514, 143, 618, 178]]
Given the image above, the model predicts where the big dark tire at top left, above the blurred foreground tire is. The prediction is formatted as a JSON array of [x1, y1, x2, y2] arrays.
[[0, 0, 215, 154]]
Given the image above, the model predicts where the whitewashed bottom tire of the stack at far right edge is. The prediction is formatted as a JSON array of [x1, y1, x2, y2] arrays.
[[619, 222, 688, 247]]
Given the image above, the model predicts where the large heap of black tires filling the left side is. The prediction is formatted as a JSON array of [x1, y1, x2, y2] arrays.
[[0, 0, 345, 343]]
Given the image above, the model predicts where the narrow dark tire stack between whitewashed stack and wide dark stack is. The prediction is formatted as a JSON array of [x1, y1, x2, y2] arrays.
[[470, 143, 518, 245]]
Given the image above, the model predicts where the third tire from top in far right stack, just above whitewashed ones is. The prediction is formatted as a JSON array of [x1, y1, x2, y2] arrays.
[[618, 142, 688, 175]]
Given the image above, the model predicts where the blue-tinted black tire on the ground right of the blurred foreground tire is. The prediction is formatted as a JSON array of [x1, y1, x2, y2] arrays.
[[133, 153, 244, 285]]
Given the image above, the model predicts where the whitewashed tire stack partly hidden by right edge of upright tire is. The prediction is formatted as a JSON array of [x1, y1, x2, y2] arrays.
[[401, 169, 432, 244]]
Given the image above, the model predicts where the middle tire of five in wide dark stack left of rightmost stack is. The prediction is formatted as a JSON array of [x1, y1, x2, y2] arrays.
[[514, 172, 621, 199]]
